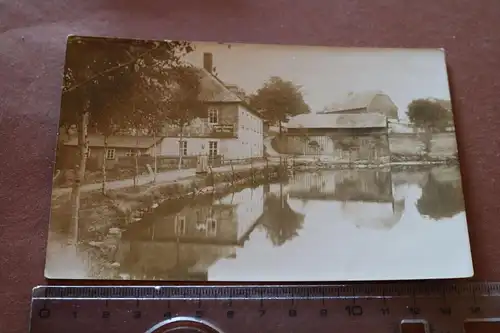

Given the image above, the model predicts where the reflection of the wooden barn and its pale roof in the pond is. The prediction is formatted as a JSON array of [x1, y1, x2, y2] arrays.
[[287, 169, 404, 229]]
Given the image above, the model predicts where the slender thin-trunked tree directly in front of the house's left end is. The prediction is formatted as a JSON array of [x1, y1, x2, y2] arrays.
[[165, 66, 207, 170]]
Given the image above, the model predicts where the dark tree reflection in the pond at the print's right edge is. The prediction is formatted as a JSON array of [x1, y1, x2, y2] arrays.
[[417, 174, 464, 220]]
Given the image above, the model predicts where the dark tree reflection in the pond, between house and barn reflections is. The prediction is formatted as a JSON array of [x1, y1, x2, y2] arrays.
[[260, 187, 304, 246]]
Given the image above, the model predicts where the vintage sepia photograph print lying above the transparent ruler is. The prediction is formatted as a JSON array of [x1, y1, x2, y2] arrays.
[[45, 36, 473, 282]]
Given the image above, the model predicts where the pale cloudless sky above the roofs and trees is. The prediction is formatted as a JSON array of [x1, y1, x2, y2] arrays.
[[182, 43, 450, 119]]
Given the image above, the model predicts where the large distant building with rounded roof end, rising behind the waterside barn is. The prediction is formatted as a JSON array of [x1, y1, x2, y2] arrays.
[[318, 91, 399, 121]]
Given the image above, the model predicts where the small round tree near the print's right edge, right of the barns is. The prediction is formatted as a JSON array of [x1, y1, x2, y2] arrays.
[[407, 99, 453, 153]]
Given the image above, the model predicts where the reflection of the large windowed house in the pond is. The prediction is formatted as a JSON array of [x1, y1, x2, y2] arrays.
[[116, 187, 264, 280]]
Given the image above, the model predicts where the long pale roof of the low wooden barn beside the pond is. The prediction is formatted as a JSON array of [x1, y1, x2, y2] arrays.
[[287, 113, 387, 129]]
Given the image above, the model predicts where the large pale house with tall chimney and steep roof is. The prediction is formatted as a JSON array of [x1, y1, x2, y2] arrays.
[[159, 53, 264, 159]]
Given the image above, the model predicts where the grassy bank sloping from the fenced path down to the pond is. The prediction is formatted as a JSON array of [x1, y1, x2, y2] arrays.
[[51, 165, 287, 239]]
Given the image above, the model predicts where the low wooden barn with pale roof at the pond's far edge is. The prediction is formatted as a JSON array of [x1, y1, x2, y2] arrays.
[[286, 113, 390, 163]]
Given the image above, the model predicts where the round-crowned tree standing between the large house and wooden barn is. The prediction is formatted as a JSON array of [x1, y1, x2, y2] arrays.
[[249, 76, 311, 135]]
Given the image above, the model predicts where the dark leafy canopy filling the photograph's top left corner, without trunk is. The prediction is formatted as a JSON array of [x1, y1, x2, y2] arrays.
[[60, 37, 193, 134]]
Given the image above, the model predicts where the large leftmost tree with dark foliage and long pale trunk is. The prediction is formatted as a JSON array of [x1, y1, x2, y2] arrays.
[[60, 37, 193, 239]]
